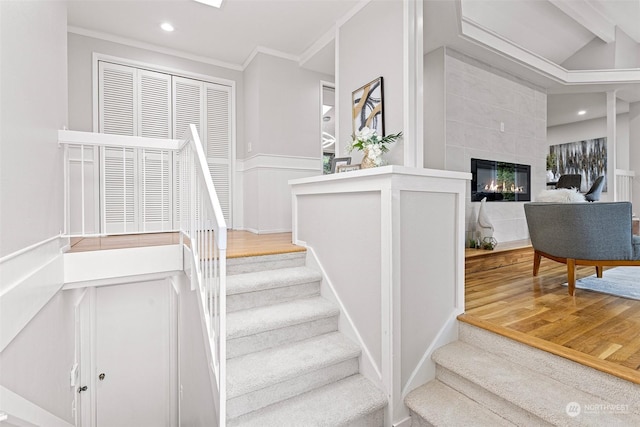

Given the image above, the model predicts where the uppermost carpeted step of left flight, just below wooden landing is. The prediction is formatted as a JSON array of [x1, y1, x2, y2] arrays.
[[227, 267, 322, 313]]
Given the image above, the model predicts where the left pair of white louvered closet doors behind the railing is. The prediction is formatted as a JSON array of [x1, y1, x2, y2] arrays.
[[99, 62, 173, 234]]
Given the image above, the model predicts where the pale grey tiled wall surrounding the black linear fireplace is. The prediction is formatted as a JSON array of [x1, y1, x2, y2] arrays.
[[425, 49, 548, 242]]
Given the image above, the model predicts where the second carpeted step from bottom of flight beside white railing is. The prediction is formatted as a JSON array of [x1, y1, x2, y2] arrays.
[[227, 332, 360, 418]]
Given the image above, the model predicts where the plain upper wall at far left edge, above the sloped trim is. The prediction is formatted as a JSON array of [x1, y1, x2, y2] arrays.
[[0, 1, 67, 257]]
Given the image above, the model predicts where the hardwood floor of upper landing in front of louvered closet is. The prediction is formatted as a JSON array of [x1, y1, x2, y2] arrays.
[[69, 230, 306, 258]]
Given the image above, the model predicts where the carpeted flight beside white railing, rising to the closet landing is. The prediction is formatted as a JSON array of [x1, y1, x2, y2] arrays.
[[227, 253, 387, 427]]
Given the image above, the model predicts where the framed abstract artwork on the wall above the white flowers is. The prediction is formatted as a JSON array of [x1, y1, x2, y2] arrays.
[[351, 77, 384, 136]]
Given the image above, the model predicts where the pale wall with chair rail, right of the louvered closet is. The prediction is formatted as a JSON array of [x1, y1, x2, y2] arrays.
[[238, 53, 333, 233]]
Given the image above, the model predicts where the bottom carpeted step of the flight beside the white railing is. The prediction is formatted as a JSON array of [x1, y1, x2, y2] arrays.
[[227, 374, 387, 427]]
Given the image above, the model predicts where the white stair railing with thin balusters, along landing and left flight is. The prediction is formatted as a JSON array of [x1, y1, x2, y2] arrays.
[[58, 129, 227, 427]]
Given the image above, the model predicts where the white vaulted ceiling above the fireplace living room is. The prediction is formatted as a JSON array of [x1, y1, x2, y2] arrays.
[[424, 0, 640, 126]]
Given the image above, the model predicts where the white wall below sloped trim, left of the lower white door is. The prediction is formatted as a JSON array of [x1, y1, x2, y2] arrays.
[[0, 290, 79, 423]]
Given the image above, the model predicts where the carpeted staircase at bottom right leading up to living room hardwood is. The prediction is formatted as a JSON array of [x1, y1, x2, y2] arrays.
[[405, 323, 640, 427]]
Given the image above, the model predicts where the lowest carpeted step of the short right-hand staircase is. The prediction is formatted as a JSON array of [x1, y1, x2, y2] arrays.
[[404, 380, 515, 427]]
